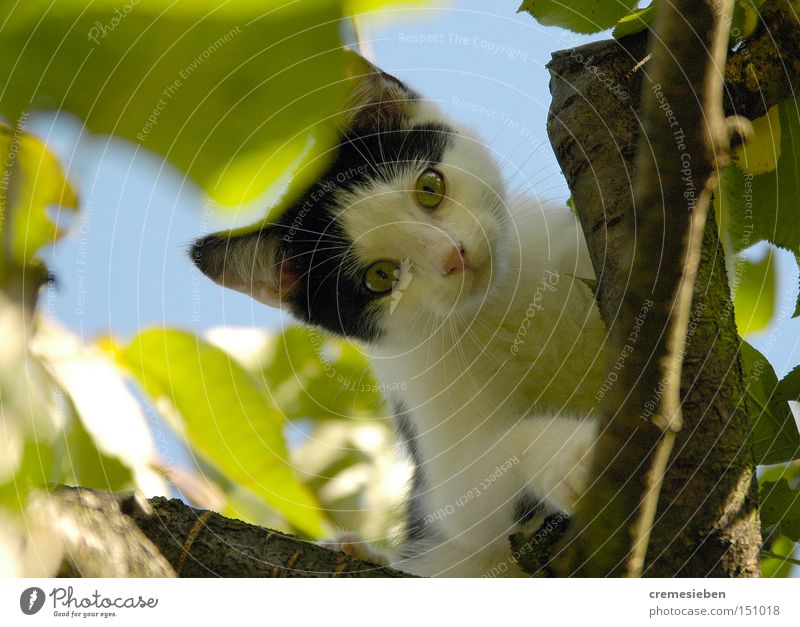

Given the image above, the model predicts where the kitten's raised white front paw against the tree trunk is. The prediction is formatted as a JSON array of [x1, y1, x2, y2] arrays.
[[531, 423, 597, 514]]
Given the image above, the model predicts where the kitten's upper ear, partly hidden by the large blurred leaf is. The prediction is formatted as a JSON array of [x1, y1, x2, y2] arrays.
[[347, 51, 419, 131]]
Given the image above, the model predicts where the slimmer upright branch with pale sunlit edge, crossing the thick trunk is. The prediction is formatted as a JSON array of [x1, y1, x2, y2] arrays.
[[559, 0, 732, 576]]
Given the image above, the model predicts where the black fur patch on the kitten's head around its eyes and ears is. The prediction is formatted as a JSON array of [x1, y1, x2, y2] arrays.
[[190, 119, 453, 341]]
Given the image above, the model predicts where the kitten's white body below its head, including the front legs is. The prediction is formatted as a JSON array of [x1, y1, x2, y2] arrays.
[[372, 198, 605, 576]]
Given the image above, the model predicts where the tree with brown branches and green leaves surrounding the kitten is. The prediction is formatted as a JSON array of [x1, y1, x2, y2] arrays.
[[0, 0, 800, 576]]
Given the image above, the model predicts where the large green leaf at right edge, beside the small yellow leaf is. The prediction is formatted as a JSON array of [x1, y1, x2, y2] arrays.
[[718, 100, 800, 254]]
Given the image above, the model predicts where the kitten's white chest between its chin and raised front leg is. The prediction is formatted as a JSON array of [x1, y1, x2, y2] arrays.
[[374, 284, 605, 426]]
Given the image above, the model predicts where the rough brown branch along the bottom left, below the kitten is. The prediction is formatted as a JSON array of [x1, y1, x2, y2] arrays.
[[47, 488, 410, 577]]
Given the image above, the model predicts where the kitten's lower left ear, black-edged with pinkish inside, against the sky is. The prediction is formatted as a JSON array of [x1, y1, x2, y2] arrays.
[[189, 229, 297, 307]]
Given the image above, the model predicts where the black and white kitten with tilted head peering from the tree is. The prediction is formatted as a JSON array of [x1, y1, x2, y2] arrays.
[[191, 56, 606, 576]]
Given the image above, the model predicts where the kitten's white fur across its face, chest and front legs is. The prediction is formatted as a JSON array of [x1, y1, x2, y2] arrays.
[[341, 107, 605, 576]]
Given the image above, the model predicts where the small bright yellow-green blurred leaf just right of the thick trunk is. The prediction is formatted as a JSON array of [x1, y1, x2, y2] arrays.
[[733, 248, 778, 336]]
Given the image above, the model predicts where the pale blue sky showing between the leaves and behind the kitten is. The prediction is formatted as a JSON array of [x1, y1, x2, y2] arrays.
[[31, 0, 800, 375]]
